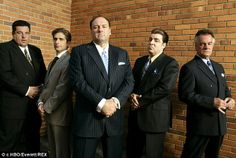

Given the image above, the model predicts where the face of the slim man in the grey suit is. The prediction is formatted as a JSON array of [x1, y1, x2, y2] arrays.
[[53, 32, 69, 53]]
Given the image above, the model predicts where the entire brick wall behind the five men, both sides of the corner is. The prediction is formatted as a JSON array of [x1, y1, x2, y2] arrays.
[[0, 0, 236, 158]]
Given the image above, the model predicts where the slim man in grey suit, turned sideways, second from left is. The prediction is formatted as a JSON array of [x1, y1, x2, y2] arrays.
[[38, 28, 72, 158]]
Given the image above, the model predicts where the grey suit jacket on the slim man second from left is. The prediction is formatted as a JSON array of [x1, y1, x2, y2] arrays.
[[38, 52, 72, 126]]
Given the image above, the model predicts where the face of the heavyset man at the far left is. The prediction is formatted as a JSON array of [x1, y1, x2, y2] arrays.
[[12, 26, 30, 47]]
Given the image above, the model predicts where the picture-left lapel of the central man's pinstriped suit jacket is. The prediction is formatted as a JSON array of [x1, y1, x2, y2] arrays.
[[87, 42, 110, 81]]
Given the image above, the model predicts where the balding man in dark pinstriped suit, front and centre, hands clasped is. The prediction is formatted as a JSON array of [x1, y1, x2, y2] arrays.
[[69, 16, 134, 158]]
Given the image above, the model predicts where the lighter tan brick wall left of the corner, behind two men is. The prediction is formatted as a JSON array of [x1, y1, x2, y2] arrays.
[[0, 0, 71, 135]]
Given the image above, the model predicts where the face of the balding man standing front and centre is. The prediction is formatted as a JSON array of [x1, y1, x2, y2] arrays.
[[91, 17, 111, 44]]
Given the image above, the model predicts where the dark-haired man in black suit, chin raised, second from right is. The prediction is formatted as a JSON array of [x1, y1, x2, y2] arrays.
[[127, 28, 179, 158]]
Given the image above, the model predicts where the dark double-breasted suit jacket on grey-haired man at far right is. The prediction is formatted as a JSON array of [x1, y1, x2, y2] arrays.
[[179, 56, 231, 136]]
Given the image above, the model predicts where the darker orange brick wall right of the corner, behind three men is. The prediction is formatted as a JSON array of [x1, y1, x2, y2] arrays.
[[71, 0, 236, 158]]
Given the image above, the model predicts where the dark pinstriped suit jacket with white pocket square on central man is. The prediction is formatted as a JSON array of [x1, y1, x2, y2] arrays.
[[70, 42, 134, 137]]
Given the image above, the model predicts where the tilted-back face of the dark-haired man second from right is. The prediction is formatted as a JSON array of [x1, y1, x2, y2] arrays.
[[148, 34, 166, 57]]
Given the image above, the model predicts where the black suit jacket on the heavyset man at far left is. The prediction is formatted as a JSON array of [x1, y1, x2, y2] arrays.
[[0, 40, 46, 119]]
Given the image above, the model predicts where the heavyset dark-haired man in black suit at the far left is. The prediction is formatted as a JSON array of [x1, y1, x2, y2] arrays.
[[0, 20, 46, 152]]
